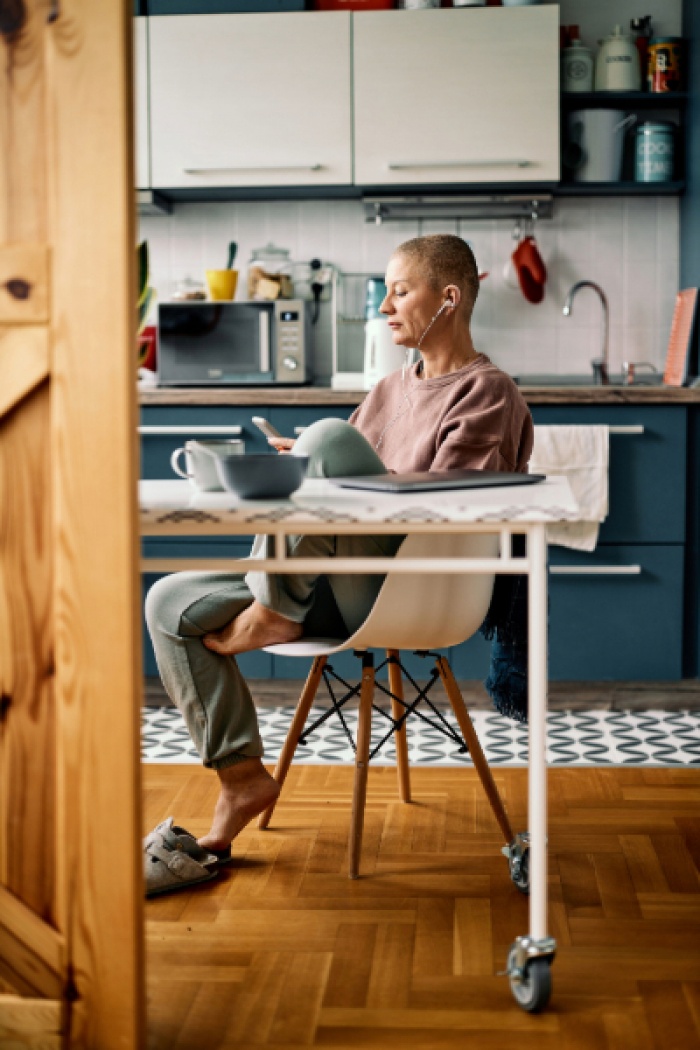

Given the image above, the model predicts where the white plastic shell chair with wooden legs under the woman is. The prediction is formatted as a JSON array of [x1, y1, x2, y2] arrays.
[[258, 533, 528, 877]]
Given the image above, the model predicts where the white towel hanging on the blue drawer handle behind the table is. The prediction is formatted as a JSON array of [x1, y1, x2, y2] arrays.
[[529, 425, 610, 550]]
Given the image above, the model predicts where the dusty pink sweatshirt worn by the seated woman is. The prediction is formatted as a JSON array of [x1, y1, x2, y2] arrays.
[[349, 354, 533, 474]]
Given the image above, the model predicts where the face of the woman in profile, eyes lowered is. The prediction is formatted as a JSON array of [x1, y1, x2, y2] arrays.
[[379, 255, 445, 347]]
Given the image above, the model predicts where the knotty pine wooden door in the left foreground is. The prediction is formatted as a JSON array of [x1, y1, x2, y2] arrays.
[[0, 0, 145, 1050]]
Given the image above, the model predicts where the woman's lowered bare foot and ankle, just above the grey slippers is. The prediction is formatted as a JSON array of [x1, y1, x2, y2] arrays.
[[197, 758, 279, 849]]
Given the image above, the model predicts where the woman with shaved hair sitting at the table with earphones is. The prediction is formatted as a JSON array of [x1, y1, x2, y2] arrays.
[[146, 234, 533, 886]]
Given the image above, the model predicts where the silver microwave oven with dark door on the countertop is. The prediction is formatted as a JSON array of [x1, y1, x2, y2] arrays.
[[157, 299, 312, 386]]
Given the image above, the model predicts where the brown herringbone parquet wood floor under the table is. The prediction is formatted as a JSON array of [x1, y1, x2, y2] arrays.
[[145, 765, 700, 1050]]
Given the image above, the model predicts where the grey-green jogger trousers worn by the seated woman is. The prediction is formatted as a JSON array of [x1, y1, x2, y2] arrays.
[[146, 419, 403, 770]]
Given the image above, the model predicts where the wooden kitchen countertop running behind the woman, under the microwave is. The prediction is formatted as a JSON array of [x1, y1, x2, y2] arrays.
[[139, 385, 700, 405]]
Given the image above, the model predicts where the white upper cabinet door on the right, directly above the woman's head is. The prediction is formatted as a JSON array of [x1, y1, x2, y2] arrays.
[[354, 4, 559, 186]]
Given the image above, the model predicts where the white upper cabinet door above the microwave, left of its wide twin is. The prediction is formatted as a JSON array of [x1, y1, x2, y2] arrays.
[[149, 12, 353, 189]]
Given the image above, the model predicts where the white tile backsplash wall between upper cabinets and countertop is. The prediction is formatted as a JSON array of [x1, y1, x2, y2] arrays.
[[140, 197, 679, 381]]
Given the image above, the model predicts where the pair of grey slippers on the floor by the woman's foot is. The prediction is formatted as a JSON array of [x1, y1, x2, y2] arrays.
[[144, 817, 231, 897]]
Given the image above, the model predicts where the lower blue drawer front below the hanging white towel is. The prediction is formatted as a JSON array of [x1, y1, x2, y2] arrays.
[[549, 544, 684, 681]]
